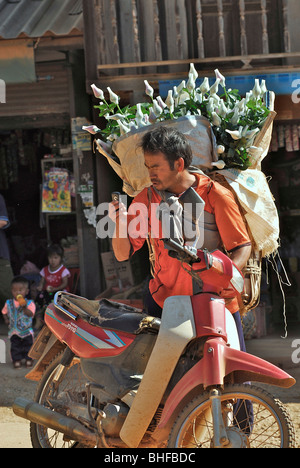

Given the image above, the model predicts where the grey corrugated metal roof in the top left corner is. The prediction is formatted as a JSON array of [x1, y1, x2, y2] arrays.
[[0, 0, 83, 39]]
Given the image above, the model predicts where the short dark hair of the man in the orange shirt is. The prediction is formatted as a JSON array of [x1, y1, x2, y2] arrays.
[[140, 126, 193, 169]]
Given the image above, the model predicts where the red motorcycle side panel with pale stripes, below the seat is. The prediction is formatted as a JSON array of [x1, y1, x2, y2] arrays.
[[45, 305, 135, 358]]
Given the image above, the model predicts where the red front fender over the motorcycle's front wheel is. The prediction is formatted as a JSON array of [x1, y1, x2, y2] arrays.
[[153, 338, 296, 440]]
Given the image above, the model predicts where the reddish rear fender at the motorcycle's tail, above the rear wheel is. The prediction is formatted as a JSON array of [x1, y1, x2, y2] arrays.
[[26, 325, 65, 381]]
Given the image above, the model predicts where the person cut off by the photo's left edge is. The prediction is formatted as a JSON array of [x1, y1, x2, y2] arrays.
[[0, 195, 13, 307]]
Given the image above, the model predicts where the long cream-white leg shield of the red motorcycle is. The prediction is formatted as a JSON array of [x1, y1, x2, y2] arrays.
[[120, 296, 196, 448]]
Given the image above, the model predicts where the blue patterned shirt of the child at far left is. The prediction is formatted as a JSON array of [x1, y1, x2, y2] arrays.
[[2, 299, 35, 338]]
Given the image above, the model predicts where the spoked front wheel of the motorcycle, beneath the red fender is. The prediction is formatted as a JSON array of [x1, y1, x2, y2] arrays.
[[168, 384, 295, 449]]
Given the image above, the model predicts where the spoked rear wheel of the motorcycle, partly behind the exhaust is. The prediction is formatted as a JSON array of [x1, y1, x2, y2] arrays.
[[30, 353, 86, 448]]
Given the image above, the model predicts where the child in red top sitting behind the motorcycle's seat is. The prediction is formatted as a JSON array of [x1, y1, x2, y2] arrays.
[[36, 244, 71, 306]]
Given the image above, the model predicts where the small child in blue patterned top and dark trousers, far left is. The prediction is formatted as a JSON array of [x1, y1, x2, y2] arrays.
[[2, 276, 35, 369]]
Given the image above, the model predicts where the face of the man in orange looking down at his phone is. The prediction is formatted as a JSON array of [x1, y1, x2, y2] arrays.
[[144, 152, 178, 192]]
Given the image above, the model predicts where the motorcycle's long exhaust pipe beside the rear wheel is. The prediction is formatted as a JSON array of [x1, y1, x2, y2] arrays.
[[12, 398, 97, 447]]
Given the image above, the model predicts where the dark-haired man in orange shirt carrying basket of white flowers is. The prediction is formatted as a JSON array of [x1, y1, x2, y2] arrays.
[[110, 126, 251, 349]]
